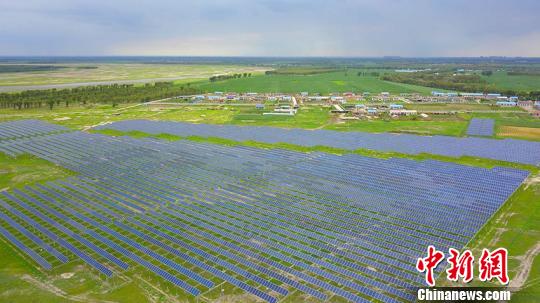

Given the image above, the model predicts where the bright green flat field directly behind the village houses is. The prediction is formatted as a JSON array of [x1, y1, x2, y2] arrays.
[[194, 69, 433, 95]]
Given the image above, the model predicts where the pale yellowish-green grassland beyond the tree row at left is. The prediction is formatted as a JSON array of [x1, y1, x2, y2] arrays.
[[0, 63, 267, 86]]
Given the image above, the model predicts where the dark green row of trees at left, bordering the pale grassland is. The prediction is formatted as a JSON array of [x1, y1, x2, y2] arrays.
[[0, 82, 199, 109]]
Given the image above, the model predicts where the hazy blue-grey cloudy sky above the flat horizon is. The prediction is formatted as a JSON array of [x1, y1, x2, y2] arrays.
[[0, 0, 540, 57]]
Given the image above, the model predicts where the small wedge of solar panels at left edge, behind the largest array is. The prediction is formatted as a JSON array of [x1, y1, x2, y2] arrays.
[[0, 120, 67, 141]]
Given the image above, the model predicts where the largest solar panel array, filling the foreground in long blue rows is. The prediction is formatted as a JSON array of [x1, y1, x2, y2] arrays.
[[0, 120, 528, 302]]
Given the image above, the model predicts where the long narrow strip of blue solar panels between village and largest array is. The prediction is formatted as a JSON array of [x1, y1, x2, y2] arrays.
[[98, 120, 540, 165]]
